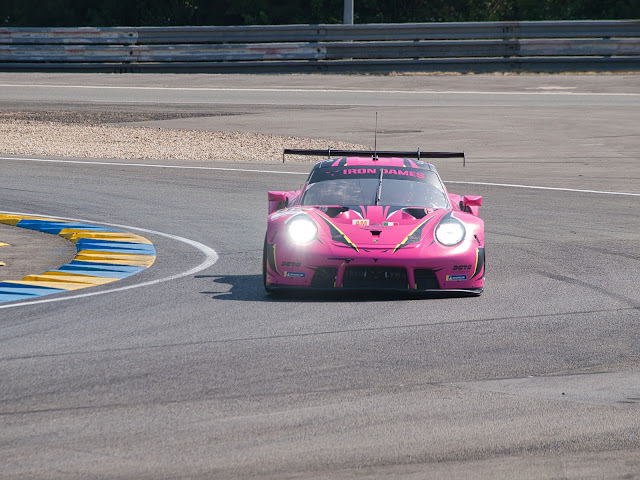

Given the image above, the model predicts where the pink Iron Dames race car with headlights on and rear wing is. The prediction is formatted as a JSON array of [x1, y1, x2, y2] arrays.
[[262, 150, 485, 295]]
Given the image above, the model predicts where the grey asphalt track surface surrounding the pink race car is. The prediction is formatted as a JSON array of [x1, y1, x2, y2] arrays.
[[0, 74, 640, 479]]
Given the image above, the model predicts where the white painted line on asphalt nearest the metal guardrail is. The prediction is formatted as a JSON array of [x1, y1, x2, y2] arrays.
[[0, 83, 640, 97]]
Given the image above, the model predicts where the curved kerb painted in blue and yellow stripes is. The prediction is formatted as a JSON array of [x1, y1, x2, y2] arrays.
[[0, 214, 156, 302]]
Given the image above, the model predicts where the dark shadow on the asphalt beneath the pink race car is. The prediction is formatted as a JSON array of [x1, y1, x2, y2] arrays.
[[195, 275, 476, 303]]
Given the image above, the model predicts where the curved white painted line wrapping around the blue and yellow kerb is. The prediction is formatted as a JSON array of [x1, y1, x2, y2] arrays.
[[0, 212, 218, 310]]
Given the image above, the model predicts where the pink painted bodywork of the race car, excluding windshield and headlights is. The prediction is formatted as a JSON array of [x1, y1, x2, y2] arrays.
[[264, 157, 485, 293]]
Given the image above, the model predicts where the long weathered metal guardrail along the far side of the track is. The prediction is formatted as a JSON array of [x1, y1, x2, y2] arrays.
[[0, 20, 640, 71]]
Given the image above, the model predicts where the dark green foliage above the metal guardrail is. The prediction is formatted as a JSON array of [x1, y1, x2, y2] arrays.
[[0, 0, 640, 27]]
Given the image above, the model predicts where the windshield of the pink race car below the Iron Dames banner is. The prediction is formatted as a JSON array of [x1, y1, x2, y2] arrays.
[[302, 167, 448, 208]]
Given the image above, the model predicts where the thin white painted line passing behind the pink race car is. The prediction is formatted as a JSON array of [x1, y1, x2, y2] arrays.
[[0, 157, 640, 197]]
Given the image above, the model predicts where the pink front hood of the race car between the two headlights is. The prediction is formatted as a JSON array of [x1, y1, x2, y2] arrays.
[[309, 206, 450, 249]]
